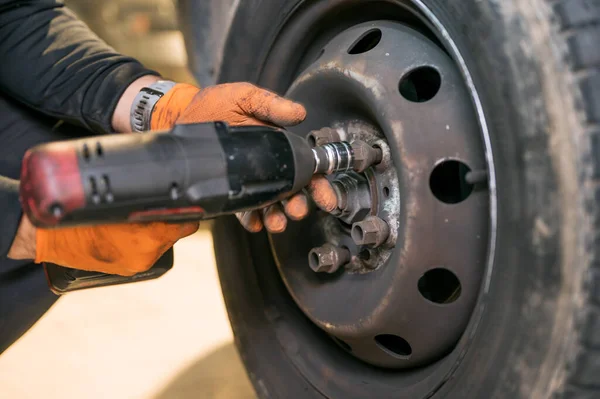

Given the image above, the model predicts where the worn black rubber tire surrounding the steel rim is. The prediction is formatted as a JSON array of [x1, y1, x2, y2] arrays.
[[205, 0, 600, 399]]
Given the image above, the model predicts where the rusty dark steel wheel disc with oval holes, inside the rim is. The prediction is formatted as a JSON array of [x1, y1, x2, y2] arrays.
[[270, 21, 489, 368]]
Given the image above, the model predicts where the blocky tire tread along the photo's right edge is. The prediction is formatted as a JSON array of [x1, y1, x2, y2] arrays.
[[552, 0, 600, 399]]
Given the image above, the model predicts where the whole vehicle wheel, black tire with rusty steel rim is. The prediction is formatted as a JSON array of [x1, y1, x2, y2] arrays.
[[204, 0, 600, 399]]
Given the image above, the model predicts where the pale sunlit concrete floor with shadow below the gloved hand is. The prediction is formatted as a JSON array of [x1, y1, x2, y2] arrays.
[[0, 229, 255, 399]]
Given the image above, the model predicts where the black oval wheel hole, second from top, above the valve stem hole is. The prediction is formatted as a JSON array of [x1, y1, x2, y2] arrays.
[[399, 66, 442, 103]]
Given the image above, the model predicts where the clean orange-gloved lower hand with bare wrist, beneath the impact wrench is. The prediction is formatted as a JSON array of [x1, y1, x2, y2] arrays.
[[8, 216, 198, 276]]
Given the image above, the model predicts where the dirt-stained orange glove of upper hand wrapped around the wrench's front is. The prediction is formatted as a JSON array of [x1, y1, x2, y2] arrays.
[[150, 83, 337, 233]]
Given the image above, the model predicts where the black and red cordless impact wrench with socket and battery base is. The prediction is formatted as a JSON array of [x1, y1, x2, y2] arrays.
[[20, 122, 370, 294]]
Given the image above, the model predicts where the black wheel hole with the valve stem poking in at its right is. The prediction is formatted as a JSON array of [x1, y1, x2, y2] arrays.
[[429, 160, 473, 204]]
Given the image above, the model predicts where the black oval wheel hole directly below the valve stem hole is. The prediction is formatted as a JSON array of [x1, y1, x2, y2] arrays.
[[418, 268, 462, 304]]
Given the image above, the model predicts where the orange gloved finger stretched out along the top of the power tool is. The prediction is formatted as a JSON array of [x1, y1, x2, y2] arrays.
[[237, 84, 306, 126]]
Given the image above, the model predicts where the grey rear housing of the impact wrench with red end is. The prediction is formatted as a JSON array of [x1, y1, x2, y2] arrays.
[[20, 123, 229, 228]]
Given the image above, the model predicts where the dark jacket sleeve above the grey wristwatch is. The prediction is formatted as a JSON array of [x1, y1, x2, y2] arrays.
[[0, 0, 156, 133]]
